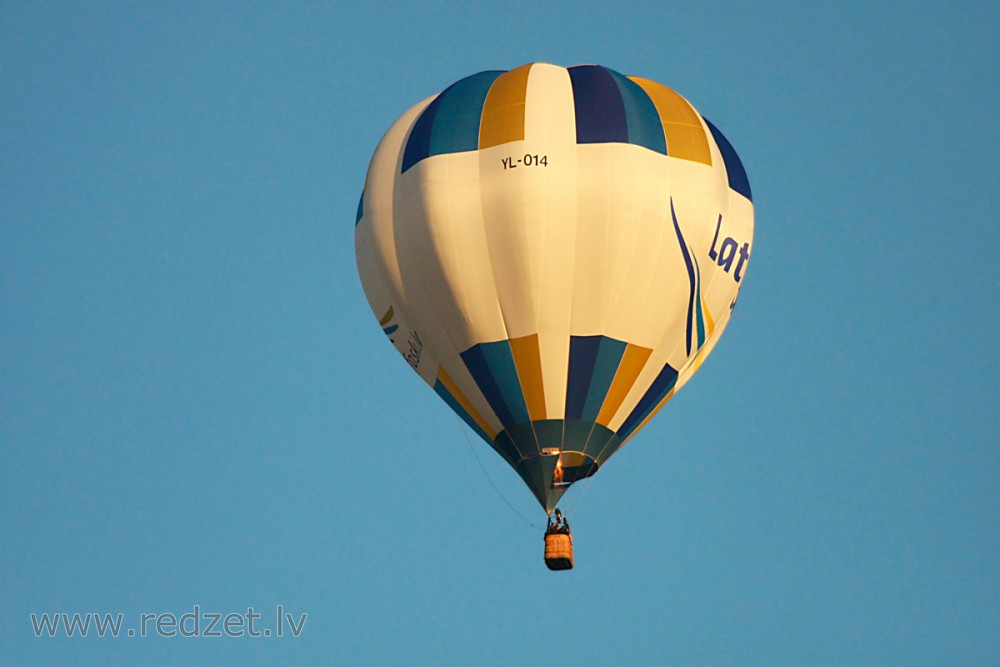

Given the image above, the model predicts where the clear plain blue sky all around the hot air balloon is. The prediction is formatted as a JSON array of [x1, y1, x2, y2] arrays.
[[0, 2, 1000, 666]]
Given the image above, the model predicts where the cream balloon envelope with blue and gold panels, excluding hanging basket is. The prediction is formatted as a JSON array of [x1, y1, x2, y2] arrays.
[[355, 63, 753, 566]]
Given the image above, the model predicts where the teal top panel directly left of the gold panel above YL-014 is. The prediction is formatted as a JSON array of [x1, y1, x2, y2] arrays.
[[430, 71, 503, 155]]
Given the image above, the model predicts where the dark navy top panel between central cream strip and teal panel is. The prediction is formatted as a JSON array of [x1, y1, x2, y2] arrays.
[[569, 65, 628, 144]]
